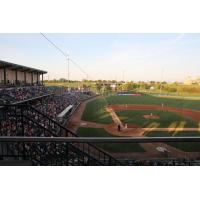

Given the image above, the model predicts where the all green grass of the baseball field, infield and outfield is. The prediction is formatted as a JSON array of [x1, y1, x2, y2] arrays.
[[78, 95, 200, 152]]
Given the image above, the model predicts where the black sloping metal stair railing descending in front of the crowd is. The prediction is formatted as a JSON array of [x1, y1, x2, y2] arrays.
[[0, 104, 122, 165]]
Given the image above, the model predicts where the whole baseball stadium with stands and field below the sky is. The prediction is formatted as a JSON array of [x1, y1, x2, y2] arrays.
[[0, 34, 200, 166]]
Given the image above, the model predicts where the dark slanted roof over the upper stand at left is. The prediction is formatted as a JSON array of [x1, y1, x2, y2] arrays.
[[0, 60, 47, 74]]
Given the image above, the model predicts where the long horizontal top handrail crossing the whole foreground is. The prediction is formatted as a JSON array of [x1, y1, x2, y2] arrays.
[[0, 136, 200, 143]]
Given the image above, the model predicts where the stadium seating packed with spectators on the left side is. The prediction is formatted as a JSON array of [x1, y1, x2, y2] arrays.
[[0, 86, 120, 165]]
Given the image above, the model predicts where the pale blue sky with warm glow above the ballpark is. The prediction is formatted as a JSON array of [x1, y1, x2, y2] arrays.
[[0, 33, 200, 81]]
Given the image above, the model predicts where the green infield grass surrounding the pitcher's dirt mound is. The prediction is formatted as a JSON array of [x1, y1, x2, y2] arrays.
[[116, 110, 198, 128]]
